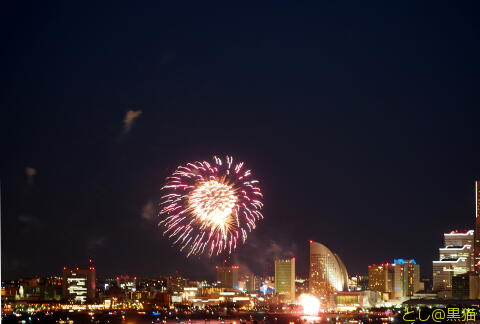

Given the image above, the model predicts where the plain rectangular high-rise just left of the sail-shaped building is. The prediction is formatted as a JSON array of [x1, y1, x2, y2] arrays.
[[275, 258, 295, 302]]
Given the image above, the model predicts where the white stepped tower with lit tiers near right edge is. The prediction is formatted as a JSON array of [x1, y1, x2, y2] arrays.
[[433, 230, 474, 297]]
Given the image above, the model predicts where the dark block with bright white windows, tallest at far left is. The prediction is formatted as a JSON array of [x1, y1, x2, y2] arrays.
[[62, 259, 96, 304]]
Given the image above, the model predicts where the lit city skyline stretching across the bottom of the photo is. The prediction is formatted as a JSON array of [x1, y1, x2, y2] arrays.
[[2, 192, 480, 312]]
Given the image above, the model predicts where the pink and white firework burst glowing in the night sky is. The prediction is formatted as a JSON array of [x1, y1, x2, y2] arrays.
[[160, 156, 263, 256]]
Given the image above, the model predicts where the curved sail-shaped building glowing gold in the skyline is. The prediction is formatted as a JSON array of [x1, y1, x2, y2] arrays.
[[309, 241, 348, 308]]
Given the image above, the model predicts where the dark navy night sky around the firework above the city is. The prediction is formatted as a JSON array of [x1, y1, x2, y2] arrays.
[[0, 1, 480, 278]]
